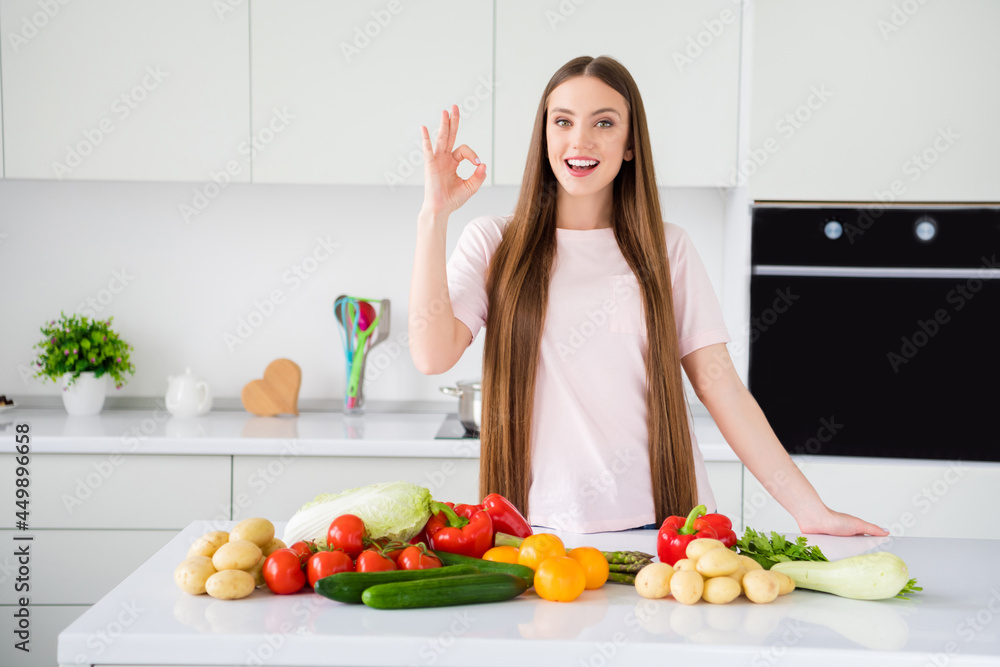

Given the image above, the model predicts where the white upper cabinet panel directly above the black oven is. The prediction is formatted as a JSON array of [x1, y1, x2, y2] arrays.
[[752, 0, 1000, 202]]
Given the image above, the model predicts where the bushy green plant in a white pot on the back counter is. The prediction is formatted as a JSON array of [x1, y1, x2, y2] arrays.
[[35, 313, 135, 416]]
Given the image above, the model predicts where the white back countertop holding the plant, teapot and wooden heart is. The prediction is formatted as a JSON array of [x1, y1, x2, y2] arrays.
[[0, 408, 739, 461]]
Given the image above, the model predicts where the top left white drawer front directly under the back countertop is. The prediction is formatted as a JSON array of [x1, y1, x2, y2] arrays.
[[0, 454, 232, 531]]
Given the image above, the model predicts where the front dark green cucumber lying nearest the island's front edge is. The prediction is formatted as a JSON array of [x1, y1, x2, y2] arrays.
[[361, 566, 528, 609]]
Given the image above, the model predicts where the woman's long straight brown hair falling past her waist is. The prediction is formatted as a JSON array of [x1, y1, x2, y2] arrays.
[[479, 56, 698, 524]]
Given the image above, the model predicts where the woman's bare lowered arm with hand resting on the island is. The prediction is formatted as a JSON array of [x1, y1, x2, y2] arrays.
[[681, 343, 888, 535]]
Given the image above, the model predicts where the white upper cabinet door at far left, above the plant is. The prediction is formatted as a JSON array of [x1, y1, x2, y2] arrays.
[[0, 0, 250, 183]]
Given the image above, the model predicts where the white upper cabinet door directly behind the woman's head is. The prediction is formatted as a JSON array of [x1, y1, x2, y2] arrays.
[[493, 0, 741, 187]]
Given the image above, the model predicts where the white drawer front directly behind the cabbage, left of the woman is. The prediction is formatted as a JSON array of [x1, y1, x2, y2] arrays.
[[236, 456, 479, 521]]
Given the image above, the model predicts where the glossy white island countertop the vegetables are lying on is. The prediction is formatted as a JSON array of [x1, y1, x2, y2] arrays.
[[58, 521, 1000, 667]]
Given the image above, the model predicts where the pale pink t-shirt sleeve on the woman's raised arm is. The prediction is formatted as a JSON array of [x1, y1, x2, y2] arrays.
[[446, 216, 505, 340]]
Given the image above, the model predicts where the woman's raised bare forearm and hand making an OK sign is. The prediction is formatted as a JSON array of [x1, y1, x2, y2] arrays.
[[408, 105, 486, 375]]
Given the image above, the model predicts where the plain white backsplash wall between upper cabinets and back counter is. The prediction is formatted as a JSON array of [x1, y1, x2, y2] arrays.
[[0, 180, 733, 403]]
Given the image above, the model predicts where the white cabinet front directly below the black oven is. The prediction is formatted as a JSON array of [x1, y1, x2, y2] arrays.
[[743, 456, 1000, 539]]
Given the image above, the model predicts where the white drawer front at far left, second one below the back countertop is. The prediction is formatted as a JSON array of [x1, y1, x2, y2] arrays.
[[0, 530, 177, 608]]
